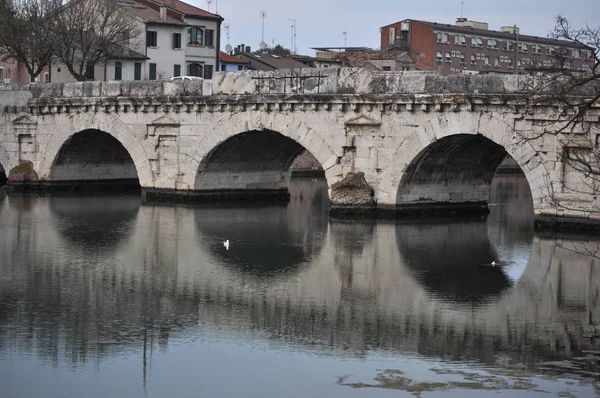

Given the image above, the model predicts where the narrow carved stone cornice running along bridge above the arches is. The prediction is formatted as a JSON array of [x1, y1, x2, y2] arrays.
[[22, 94, 548, 115]]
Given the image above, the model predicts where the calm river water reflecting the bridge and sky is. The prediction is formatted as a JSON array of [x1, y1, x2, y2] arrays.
[[0, 176, 600, 398]]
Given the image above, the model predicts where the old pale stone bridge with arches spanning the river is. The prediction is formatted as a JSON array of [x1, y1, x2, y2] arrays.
[[0, 69, 600, 229]]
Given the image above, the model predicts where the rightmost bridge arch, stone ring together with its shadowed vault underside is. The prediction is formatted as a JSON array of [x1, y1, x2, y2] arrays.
[[392, 112, 549, 214]]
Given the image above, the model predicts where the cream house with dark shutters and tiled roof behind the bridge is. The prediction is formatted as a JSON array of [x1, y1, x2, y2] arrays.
[[50, 0, 223, 82]]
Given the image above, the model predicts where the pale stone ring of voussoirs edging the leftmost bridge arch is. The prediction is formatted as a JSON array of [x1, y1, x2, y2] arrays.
[[38, 113, 154, 188]]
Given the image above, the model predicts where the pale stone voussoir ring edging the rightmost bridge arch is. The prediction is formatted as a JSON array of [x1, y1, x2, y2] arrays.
[[386, 112, 549, 213]]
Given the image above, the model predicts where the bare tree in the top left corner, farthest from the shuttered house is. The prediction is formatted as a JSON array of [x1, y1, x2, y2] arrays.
[[0, 0, 61, 81]]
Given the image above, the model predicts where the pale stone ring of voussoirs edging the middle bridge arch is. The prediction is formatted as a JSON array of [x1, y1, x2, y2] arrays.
[[178, 112, 339, 188]]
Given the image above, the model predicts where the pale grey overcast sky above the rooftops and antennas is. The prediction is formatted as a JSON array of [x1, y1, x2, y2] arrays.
[[184, 0, 600, 55]]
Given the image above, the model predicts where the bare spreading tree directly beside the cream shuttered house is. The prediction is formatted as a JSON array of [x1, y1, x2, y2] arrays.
[[55, 0, 141, 81]]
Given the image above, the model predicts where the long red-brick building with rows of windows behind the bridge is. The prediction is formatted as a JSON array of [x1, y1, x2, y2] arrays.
[[380, 18, 594, 74]]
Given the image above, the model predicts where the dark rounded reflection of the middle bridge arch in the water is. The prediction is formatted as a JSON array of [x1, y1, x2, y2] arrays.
[[194, 181, 328, 277]]
